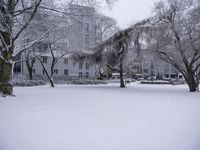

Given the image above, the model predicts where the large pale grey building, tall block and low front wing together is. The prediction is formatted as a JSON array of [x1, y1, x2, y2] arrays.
[[15, 4, 98, 79]]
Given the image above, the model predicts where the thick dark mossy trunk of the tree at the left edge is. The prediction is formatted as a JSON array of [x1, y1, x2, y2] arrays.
[[0, 0, 15, 96]]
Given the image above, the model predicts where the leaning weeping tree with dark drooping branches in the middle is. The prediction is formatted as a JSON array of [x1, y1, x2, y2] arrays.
[[72, 19, 150, 88]]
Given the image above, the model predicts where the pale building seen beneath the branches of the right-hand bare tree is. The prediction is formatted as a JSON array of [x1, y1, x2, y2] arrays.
[[132, 50, 182, 80]]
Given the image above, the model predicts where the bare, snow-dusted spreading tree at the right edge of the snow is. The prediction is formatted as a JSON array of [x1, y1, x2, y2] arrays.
[[150, 0, 200, 92]]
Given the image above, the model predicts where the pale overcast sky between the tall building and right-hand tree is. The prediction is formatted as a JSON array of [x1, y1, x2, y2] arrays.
[[102, 0, 158, 28]]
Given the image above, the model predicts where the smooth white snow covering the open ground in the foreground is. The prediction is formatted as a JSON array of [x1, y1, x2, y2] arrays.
[[0, 83, 200, 150]]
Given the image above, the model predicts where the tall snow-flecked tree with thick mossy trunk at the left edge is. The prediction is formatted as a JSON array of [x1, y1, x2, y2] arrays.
[[0, 0, 42, 95]]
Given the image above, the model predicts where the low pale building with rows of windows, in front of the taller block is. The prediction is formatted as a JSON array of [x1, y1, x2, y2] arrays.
[[23, 52, 96, 79]]
